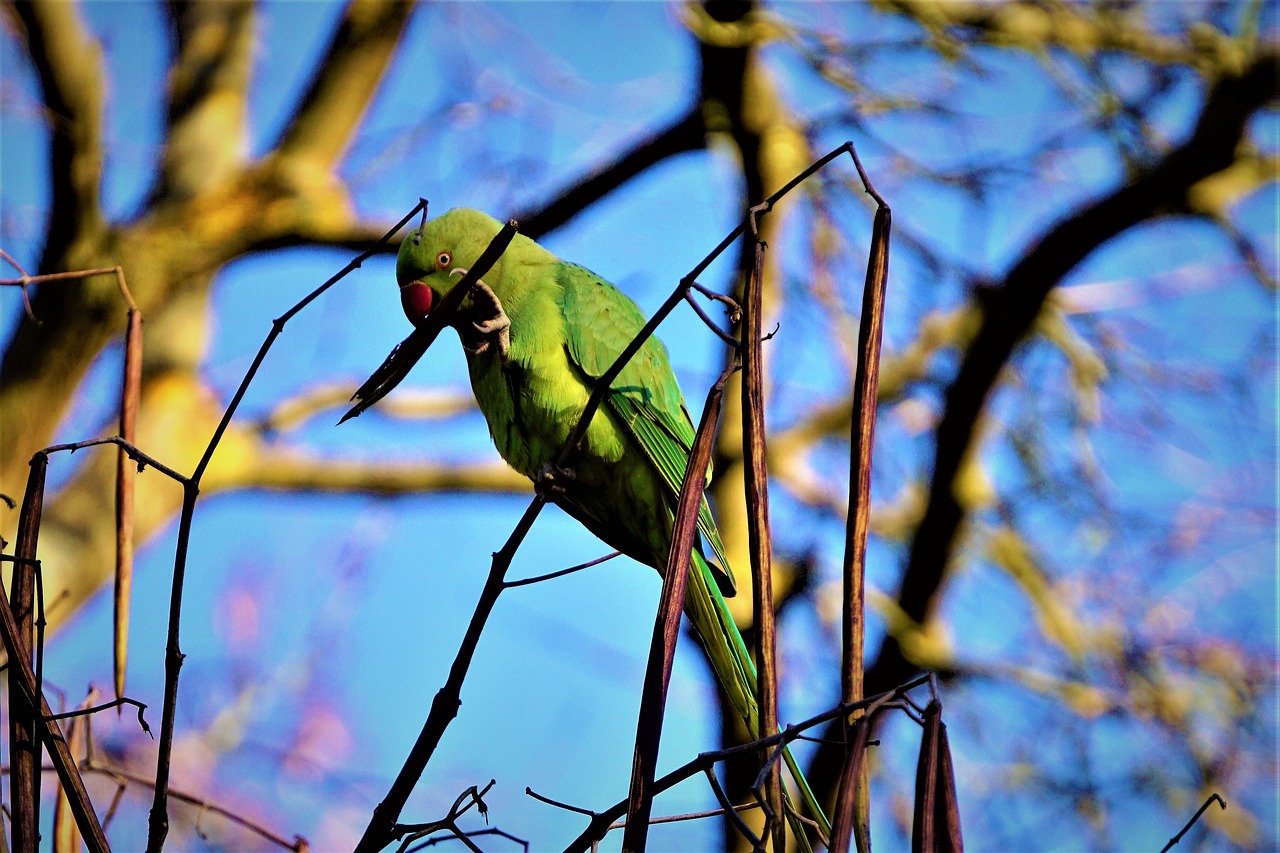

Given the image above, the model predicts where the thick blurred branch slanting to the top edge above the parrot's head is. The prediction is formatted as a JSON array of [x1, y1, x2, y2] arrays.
[[274, 0, 415, 170]]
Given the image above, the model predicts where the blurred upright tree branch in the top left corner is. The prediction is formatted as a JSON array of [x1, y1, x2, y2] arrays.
[[9, 3, 105, 262]]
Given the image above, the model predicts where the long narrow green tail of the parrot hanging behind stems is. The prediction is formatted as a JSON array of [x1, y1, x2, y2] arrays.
[[685, 551, 831, 849]]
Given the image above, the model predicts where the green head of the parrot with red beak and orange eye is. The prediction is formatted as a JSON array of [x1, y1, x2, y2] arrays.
[[396, 207, 502, 325]]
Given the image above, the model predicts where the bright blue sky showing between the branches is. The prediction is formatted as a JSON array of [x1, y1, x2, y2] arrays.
[[0, 3, 1276, 849]]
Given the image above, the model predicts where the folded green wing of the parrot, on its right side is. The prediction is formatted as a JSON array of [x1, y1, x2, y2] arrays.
[[558, 263, 736, 596]]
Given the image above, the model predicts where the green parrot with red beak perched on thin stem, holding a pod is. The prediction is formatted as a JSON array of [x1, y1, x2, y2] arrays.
[[348, 209, 829, 834]]
